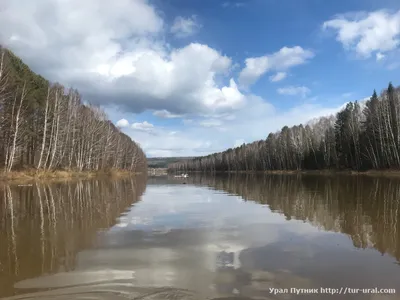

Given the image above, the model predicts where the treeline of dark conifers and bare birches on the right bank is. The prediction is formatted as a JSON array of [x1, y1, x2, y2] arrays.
[[169, 83, 400, 172]]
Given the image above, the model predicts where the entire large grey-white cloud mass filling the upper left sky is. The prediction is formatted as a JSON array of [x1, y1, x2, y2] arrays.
[[0, 0, 245, 115]]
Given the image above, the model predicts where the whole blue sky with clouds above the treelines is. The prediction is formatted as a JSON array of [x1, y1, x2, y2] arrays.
[[0, 0, 400, 157]]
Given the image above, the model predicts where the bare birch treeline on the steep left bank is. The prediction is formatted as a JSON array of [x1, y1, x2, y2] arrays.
[[0, 46, 147, 172]]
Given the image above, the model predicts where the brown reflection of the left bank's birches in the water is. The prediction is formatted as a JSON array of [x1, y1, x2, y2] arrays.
[[0, 178, 146, 297]]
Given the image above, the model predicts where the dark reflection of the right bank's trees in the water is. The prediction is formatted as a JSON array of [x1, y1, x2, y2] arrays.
[[190, 175, 400, 261]]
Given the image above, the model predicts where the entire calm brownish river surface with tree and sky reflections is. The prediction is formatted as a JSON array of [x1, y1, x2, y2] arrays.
[[0, 175, 400, 300]]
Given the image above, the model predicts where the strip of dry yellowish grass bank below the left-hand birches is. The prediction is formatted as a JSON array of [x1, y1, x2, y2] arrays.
[[0, 169, 140, 182]]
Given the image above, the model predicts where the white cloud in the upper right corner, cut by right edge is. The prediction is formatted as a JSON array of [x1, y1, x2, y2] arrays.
[[323, 10, 400, 60]]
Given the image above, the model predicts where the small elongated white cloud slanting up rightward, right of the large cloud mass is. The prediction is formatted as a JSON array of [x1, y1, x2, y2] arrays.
[[239, 46, 314, 86]]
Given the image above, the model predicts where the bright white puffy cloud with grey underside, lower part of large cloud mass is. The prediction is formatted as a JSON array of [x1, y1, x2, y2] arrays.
[[81, 43, 245, 115]]
